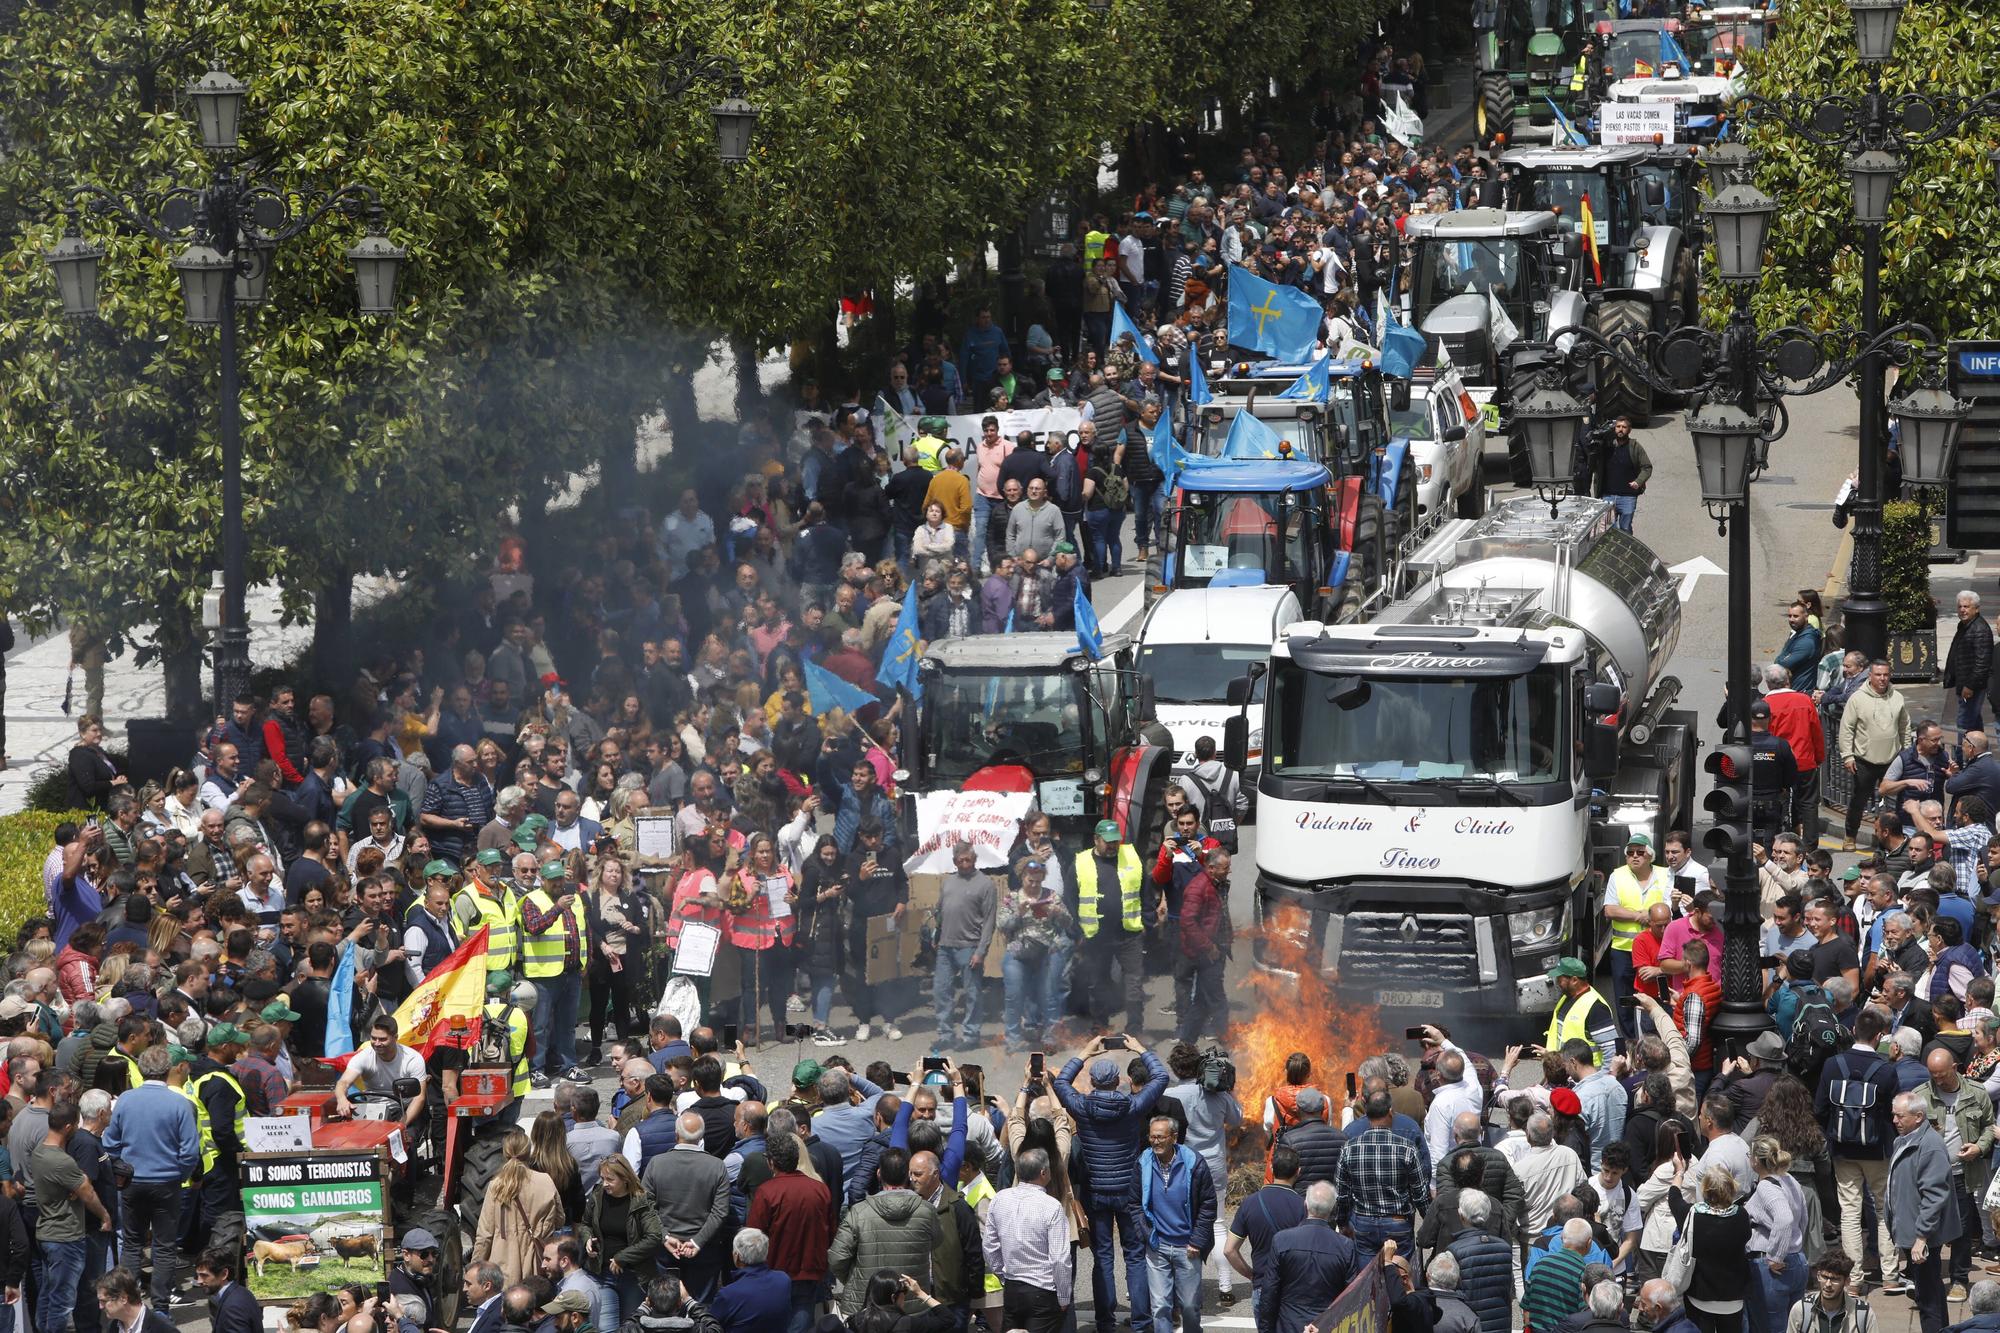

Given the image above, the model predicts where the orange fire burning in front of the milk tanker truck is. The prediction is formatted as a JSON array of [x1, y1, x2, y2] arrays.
[[1230, 905, 1394, 1183]]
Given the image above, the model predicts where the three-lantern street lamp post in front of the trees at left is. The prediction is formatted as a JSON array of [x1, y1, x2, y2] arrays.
[[46, 68, 406, 715]]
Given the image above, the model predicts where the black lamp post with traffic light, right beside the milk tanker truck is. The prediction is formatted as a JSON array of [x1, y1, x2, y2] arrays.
[[1514, 169, 1966, 1039]]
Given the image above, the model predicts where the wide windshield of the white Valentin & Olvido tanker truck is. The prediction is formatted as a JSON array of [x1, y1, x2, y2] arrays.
[[1264, 658, 1568, 783]]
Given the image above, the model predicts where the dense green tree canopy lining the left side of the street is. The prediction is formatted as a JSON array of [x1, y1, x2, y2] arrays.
[[0, 0, 1386, 696]]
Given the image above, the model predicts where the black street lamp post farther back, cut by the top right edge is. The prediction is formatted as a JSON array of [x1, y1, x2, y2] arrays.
[[1734, 0, 2000, 658]]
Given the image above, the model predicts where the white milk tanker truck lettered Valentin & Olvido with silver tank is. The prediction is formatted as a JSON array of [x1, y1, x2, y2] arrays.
[[1226, 496, 1696, 1039]]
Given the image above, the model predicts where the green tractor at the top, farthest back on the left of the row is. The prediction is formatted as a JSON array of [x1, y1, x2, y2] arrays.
[[1472, 0, 1594, 144]]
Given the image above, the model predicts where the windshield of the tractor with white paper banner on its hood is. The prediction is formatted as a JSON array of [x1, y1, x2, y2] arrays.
[[924, 671, 1096, 783]]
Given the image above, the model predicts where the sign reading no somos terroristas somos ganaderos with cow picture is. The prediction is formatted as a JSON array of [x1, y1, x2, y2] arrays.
[[242, 1153, 388, 1301]]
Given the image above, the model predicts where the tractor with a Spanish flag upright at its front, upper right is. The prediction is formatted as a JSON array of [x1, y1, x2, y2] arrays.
[[1500, 144, 1700, 422]]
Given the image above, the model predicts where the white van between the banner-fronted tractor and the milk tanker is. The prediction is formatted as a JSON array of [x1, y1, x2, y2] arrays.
[[1138, 584, 1302, 797]]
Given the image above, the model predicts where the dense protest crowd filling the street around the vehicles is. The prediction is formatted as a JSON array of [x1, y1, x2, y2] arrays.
[[27, 28, 2000, 1333]]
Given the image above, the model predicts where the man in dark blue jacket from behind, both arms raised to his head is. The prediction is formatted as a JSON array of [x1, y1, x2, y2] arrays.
[[1056, 1037, 1166, 1329]]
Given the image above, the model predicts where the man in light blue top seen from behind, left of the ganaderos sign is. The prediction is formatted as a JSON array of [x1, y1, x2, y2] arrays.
[[104, 1045, 202, 1309]]
